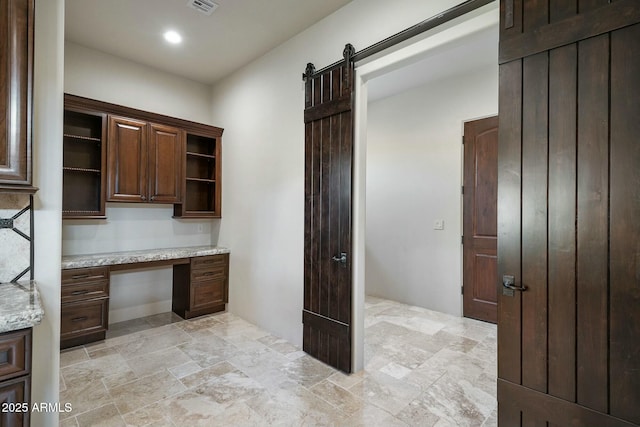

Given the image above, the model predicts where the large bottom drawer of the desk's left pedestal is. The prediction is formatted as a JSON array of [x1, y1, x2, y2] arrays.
[[60, 298, 109, 339]]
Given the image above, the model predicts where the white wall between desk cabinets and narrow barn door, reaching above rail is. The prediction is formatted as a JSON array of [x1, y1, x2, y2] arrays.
[[213, 0, 496, 344]]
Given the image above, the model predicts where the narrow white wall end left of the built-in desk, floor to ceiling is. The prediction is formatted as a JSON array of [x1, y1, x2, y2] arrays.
[[31, 0, 64, 426]]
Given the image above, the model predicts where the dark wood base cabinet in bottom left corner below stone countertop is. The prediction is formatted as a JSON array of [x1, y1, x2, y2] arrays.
[[0, 329, 31, 427]]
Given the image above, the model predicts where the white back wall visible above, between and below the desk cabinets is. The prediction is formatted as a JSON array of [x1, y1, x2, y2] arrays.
[[62, 42, 220, 323]]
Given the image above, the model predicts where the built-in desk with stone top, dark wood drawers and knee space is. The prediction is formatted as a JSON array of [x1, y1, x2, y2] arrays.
[[60, 246, 229, 348]]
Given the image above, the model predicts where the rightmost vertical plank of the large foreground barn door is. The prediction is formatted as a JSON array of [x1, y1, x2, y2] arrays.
[[609, 24, 640, 425]]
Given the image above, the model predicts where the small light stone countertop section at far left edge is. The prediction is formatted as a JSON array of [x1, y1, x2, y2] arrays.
[[0, 280, 44, 333]]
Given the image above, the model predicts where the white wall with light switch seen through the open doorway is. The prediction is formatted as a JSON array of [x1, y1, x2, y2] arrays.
[[366, 63, 498, 315]]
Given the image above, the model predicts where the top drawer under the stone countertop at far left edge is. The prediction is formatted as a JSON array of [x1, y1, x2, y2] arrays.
[[0, 329, 31, 382]]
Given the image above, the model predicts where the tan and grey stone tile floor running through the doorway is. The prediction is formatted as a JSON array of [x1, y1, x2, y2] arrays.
[[60, 297, 496, 427]]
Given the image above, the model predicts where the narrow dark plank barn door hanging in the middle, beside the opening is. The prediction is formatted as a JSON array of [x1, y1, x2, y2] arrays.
[[302, 45, 354, 372]]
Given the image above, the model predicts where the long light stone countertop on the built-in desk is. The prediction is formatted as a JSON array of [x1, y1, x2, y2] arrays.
[[62, 246, 230, 270]]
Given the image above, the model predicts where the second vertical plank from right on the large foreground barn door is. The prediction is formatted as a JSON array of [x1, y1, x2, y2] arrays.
[[576, 35, 609, 412]]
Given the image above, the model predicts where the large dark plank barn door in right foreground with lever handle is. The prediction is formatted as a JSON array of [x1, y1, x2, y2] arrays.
[[498, 0, 640, 427]]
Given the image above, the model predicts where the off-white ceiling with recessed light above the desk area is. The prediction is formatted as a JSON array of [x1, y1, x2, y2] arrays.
[[65, 0, 351, 84]]
